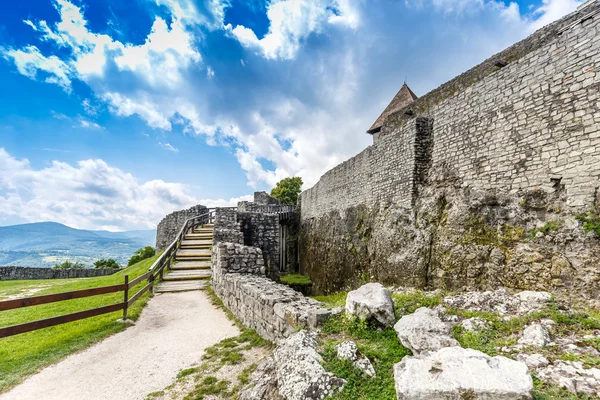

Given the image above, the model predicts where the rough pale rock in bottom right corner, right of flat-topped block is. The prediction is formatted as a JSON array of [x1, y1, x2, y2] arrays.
[[537, 361, 600, 397]]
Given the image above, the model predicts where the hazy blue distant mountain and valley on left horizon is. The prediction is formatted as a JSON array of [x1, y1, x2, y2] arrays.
[[0, 222, 156, 267]]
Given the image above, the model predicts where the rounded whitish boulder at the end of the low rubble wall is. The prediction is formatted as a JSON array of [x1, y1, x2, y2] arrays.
[[346, 283, 396, 327]]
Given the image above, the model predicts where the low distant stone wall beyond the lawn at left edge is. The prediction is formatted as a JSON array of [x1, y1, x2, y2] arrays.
[[0, 267, 120, 281]]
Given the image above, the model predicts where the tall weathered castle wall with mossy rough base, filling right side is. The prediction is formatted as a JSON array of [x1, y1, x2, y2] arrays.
[[300, 3, 600, 296]]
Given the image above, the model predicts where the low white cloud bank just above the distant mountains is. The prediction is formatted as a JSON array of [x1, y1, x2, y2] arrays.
[[0, 148, 252, 230]]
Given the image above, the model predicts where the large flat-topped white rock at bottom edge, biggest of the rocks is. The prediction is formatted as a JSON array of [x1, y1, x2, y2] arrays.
[[394, 347, 533, 400]]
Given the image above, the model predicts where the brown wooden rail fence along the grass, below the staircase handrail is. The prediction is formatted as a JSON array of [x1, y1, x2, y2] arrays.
[[0, 271, 154, 338]]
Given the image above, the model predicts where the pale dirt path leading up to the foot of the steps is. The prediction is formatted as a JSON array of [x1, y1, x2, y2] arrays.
[[0, 291, 239, 400]]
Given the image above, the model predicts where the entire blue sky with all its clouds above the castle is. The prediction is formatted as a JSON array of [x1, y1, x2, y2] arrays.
[[0, 0, 579, 230]]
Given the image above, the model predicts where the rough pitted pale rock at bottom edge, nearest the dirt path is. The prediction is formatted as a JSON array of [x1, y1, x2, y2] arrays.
[[273, 330, 345, 400]]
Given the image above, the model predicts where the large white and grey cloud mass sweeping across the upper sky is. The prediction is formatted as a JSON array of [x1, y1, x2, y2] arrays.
[[2, 0, 580, 197]]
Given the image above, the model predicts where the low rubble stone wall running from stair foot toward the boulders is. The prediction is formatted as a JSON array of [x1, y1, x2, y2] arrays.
[[212, 243, 331, 342]]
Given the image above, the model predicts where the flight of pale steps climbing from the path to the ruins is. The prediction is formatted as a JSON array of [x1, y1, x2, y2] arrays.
[[155, 224, 214, 293]]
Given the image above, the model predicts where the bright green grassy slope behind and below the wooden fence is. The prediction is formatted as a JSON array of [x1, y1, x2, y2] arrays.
[[0, 257, 156, 393]]
